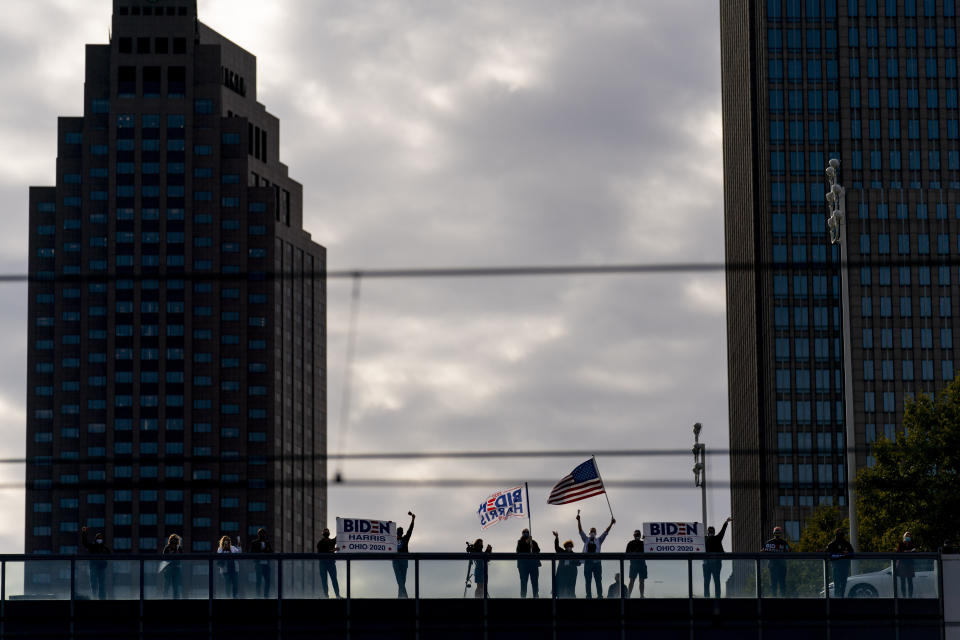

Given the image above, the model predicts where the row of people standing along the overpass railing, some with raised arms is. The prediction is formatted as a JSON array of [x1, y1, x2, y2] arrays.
[[81, 511, 957, 600]]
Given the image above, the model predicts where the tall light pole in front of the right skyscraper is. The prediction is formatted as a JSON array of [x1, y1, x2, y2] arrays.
[[826, 158, 858, 547]]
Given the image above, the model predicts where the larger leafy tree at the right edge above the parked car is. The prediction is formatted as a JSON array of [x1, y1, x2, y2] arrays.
[[856, 377, 960, 551]]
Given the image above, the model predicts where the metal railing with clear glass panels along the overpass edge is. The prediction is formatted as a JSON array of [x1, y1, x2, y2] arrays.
[[0, 553, 942, 603]]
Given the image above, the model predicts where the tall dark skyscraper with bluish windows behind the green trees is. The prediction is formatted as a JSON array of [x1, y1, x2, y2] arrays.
[[720, 0, 960, 551]]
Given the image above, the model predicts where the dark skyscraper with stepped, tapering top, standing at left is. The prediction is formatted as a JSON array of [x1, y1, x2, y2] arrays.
[[26, 0, 326, 553]]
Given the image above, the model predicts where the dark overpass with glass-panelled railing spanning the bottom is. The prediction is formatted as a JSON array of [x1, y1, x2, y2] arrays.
[[0, 553, 948, 640]]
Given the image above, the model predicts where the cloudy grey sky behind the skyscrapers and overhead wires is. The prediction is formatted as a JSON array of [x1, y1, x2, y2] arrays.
[[0, 0, 729, 553]]
